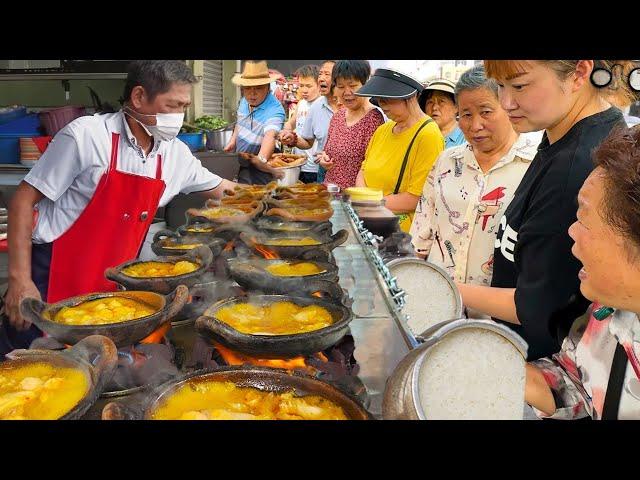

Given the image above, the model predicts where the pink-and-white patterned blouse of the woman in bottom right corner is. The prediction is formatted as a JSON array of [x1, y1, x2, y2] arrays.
[[531, 303, 640, 420]]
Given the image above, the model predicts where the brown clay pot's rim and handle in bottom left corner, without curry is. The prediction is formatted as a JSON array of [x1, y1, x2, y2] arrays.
[[2, 335, 118, 420]]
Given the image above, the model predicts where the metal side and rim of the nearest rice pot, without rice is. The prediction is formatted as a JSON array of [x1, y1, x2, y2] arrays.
[[382, 318, 528, 420]]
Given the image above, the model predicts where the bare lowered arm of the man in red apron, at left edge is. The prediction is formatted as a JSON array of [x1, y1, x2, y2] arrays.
[[5, 181, 44, 330]]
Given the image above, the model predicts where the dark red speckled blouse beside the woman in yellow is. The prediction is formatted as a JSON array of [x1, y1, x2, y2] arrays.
[[324, 108, 384, 189]]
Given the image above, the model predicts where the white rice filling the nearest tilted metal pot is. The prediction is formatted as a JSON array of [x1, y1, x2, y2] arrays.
[[418, 328, 525, 420]]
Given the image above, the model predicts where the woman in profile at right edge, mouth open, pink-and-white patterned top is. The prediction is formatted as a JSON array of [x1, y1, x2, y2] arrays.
[[525, 127, 640, 420]]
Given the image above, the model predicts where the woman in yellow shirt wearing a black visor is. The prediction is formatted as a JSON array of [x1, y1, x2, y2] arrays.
[[356, 68, 444, 232]]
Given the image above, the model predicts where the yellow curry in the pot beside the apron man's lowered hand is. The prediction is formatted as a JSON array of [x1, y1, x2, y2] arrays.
[[53, 297, 157, 325]]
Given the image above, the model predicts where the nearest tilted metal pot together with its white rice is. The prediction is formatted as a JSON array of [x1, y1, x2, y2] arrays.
[[382, 319, 527, 420]]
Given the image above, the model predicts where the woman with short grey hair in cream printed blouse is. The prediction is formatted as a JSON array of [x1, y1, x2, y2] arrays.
[[411, 65, 540, 318]]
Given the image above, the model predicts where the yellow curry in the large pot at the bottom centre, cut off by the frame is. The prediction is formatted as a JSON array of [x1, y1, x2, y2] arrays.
[[151, 380, 347, 420]]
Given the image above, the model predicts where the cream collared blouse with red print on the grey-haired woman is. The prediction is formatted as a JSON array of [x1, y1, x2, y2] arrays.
[[410, 133, 540, 285]]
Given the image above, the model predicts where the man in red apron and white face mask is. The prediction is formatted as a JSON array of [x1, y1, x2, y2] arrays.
[[0, 60, 235, 353]]
